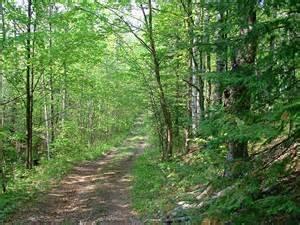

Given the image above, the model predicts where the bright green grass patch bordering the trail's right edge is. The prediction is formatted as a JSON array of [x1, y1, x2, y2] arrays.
[[132, 146, 213, 222]]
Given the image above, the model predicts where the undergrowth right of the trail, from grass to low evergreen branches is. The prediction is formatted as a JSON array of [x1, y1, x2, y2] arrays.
[[132, 136, 300, 225]]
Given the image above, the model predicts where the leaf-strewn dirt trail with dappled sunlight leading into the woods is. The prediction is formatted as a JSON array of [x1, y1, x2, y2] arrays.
[[7, 130, 146, 225]]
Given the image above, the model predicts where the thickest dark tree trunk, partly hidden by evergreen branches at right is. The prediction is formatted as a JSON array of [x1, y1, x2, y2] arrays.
[[224, 2, 257, 175]]
